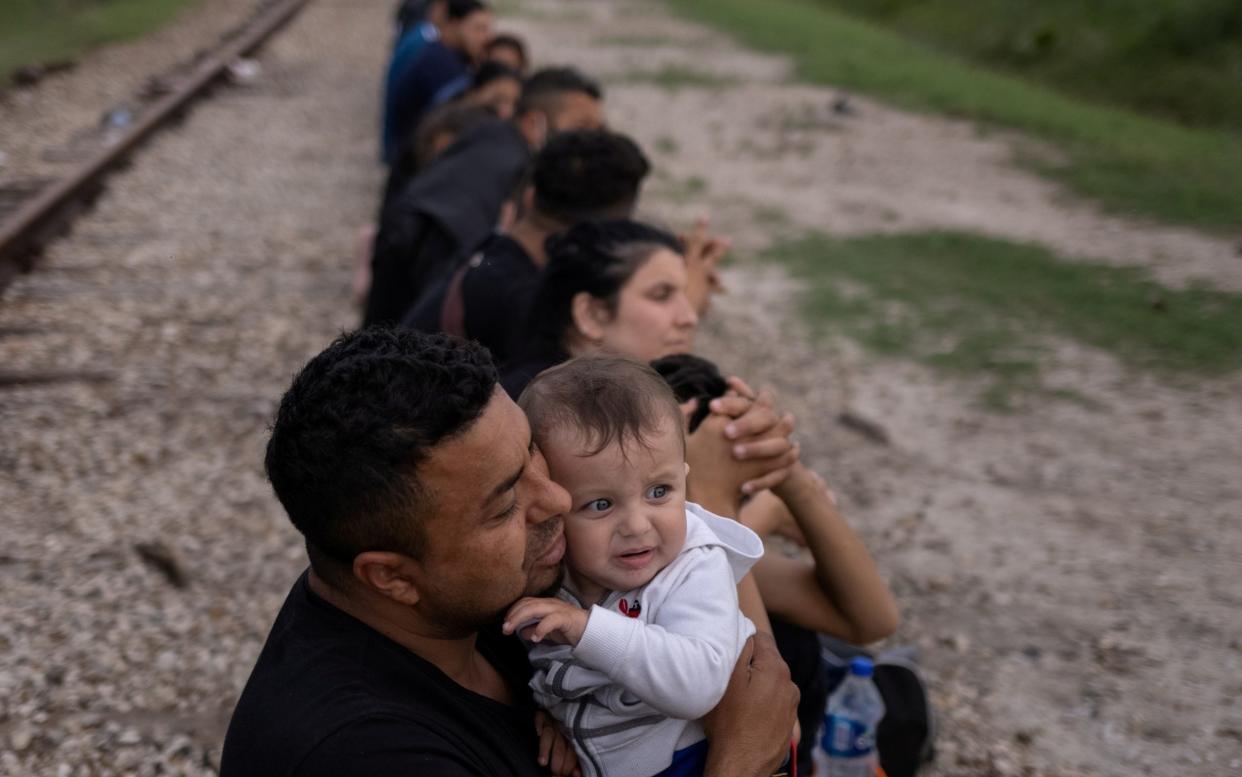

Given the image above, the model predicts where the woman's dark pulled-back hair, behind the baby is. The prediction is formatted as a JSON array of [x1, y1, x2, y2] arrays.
[[528, 218, 682, 350]]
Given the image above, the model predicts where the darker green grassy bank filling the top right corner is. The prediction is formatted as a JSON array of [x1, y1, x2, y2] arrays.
[[818, 0, 1242, 132]]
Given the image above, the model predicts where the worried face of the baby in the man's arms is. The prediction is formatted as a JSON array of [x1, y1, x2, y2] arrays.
[[540, 418, 686, 604]]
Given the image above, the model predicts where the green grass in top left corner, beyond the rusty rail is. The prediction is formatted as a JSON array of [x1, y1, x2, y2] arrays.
[[0, 0, 196, 81]]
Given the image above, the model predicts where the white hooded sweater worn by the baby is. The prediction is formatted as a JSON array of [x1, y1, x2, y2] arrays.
[[529, 503, 764, 777]]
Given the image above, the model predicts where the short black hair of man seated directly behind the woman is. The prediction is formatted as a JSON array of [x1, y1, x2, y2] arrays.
[[533, 130, 651, 225]]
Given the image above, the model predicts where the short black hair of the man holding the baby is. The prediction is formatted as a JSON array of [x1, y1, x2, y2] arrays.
[[265, 328, 497, 582]]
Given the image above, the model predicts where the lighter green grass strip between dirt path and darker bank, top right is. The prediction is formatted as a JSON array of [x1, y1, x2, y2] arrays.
[[668, 0, 1242, 231]]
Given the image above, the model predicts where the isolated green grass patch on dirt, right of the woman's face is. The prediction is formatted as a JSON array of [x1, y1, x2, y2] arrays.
[[764, 232, 1242, 407]]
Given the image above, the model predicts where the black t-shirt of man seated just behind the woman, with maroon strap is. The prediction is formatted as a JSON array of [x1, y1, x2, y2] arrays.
[[404, 235, 539, 364]]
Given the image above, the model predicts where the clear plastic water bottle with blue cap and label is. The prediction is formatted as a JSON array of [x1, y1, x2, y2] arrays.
[[811, 658, 884, 777]]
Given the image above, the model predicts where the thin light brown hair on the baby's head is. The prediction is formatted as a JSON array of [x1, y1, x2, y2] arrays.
[[518, 356, 684, 456]]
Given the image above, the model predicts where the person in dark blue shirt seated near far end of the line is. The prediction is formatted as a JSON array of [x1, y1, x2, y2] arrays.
[[383, 0, 492, 164]]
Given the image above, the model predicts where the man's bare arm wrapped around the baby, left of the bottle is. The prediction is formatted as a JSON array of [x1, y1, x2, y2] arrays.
[[703, 634, 799, 777]]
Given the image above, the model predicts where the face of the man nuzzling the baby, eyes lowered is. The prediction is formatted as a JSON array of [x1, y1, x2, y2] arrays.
[[417, 387, 569, 634]]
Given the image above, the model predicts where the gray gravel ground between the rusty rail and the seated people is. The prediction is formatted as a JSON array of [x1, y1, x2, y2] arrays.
[[0, 0, 389, 776]]
